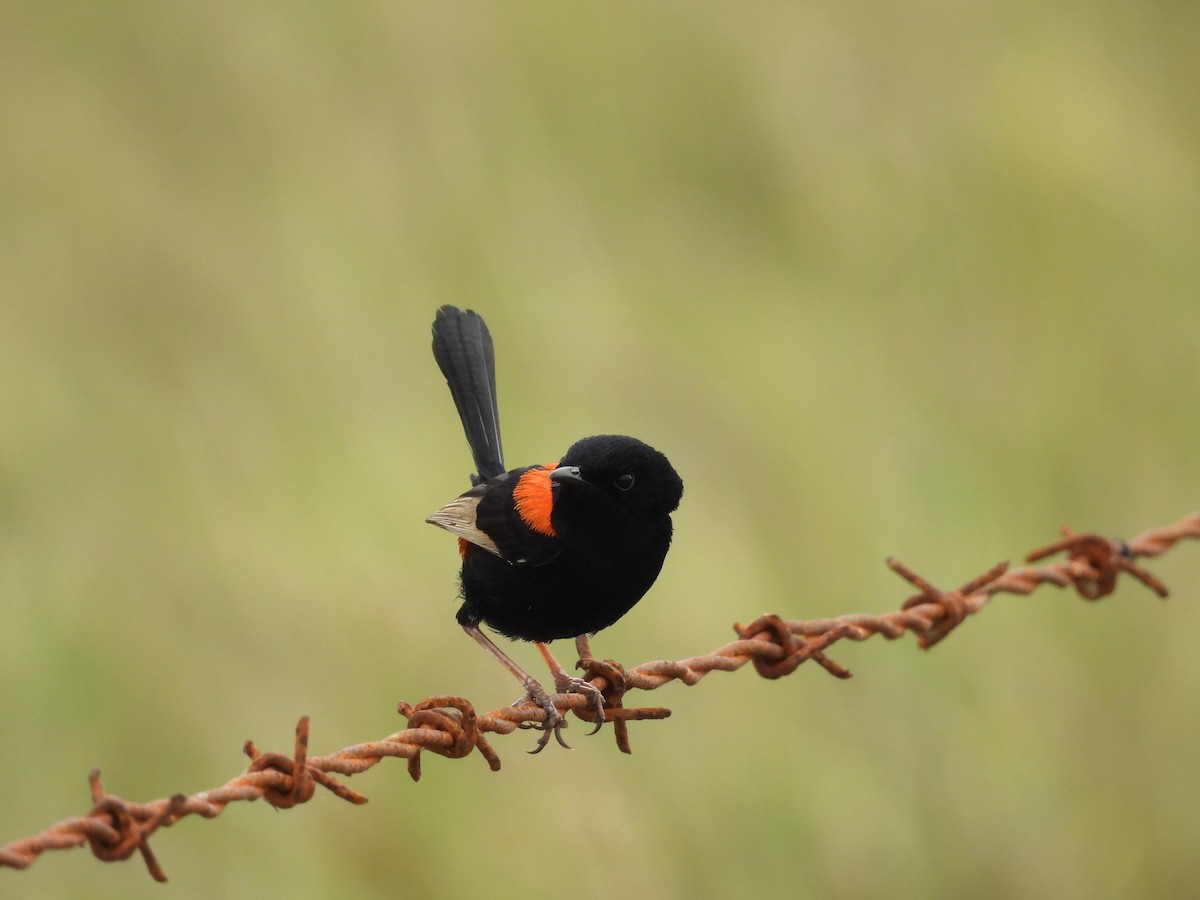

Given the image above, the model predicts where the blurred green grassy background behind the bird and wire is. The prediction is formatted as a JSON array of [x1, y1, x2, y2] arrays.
[[0, 1, 1200, 898]]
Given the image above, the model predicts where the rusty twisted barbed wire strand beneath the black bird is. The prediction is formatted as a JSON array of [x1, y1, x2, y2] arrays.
[[0, 512, 1200, 881]]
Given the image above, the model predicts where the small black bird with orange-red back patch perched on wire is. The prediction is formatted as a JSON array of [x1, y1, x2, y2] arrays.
[[426, 305, 683, 752]]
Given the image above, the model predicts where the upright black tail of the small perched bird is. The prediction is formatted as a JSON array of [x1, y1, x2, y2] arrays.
[[433, 306, 505, 484]]
